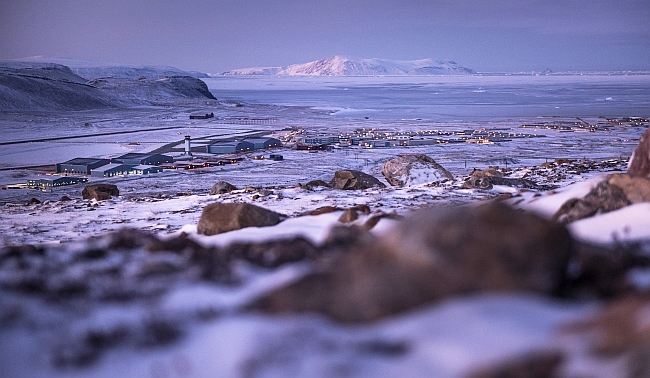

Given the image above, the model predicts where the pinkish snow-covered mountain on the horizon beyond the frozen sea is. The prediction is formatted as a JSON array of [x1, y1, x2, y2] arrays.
[[221, 55, 474, 76]]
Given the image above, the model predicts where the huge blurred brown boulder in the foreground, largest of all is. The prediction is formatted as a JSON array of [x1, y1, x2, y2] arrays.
[[251, 203, 572, 322]]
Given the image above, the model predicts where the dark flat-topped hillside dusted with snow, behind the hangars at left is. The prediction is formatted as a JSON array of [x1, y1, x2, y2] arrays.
[[0, 60, 215, 111]]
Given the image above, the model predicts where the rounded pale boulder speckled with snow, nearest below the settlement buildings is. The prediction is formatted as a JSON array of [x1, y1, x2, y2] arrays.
[[381, 154, 454, 186]]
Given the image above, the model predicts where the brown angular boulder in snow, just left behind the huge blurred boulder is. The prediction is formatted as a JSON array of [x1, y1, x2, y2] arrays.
[[197, 203, 283, 235]]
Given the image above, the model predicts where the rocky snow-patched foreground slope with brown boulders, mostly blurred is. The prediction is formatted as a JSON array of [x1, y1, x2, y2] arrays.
[[0, 131, 650, 377]]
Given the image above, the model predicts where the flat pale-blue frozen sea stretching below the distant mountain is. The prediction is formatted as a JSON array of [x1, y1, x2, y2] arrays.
[[204, 74, 650, 122]]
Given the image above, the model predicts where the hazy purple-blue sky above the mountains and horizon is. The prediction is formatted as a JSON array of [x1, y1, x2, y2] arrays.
[[0, 0, 650, 73]]
